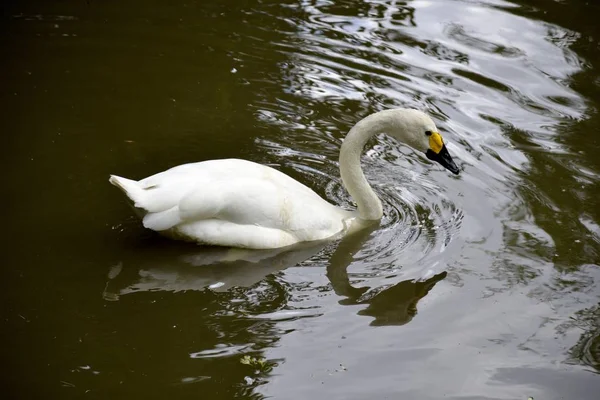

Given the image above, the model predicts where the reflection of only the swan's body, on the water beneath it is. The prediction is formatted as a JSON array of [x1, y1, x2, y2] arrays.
[[103, 238, 329, 300]]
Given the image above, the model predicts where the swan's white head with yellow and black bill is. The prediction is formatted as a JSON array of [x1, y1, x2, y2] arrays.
[[394, 109, 460, 175]]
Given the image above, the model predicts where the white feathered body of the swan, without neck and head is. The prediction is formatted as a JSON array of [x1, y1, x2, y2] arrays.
[[111, 159, 352, 249]]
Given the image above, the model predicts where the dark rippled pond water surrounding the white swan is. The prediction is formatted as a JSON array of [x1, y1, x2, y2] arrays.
[[0, 0, 600, 400]]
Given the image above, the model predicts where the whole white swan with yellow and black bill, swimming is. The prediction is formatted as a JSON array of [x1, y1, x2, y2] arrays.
[[109, 108, 459, 249]]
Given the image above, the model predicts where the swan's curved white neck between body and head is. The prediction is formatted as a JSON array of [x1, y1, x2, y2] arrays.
[[340, 111, 394, 220]]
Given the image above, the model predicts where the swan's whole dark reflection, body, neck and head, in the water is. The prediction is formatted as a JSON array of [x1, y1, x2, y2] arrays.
[[103, 224, 446, 325]]
